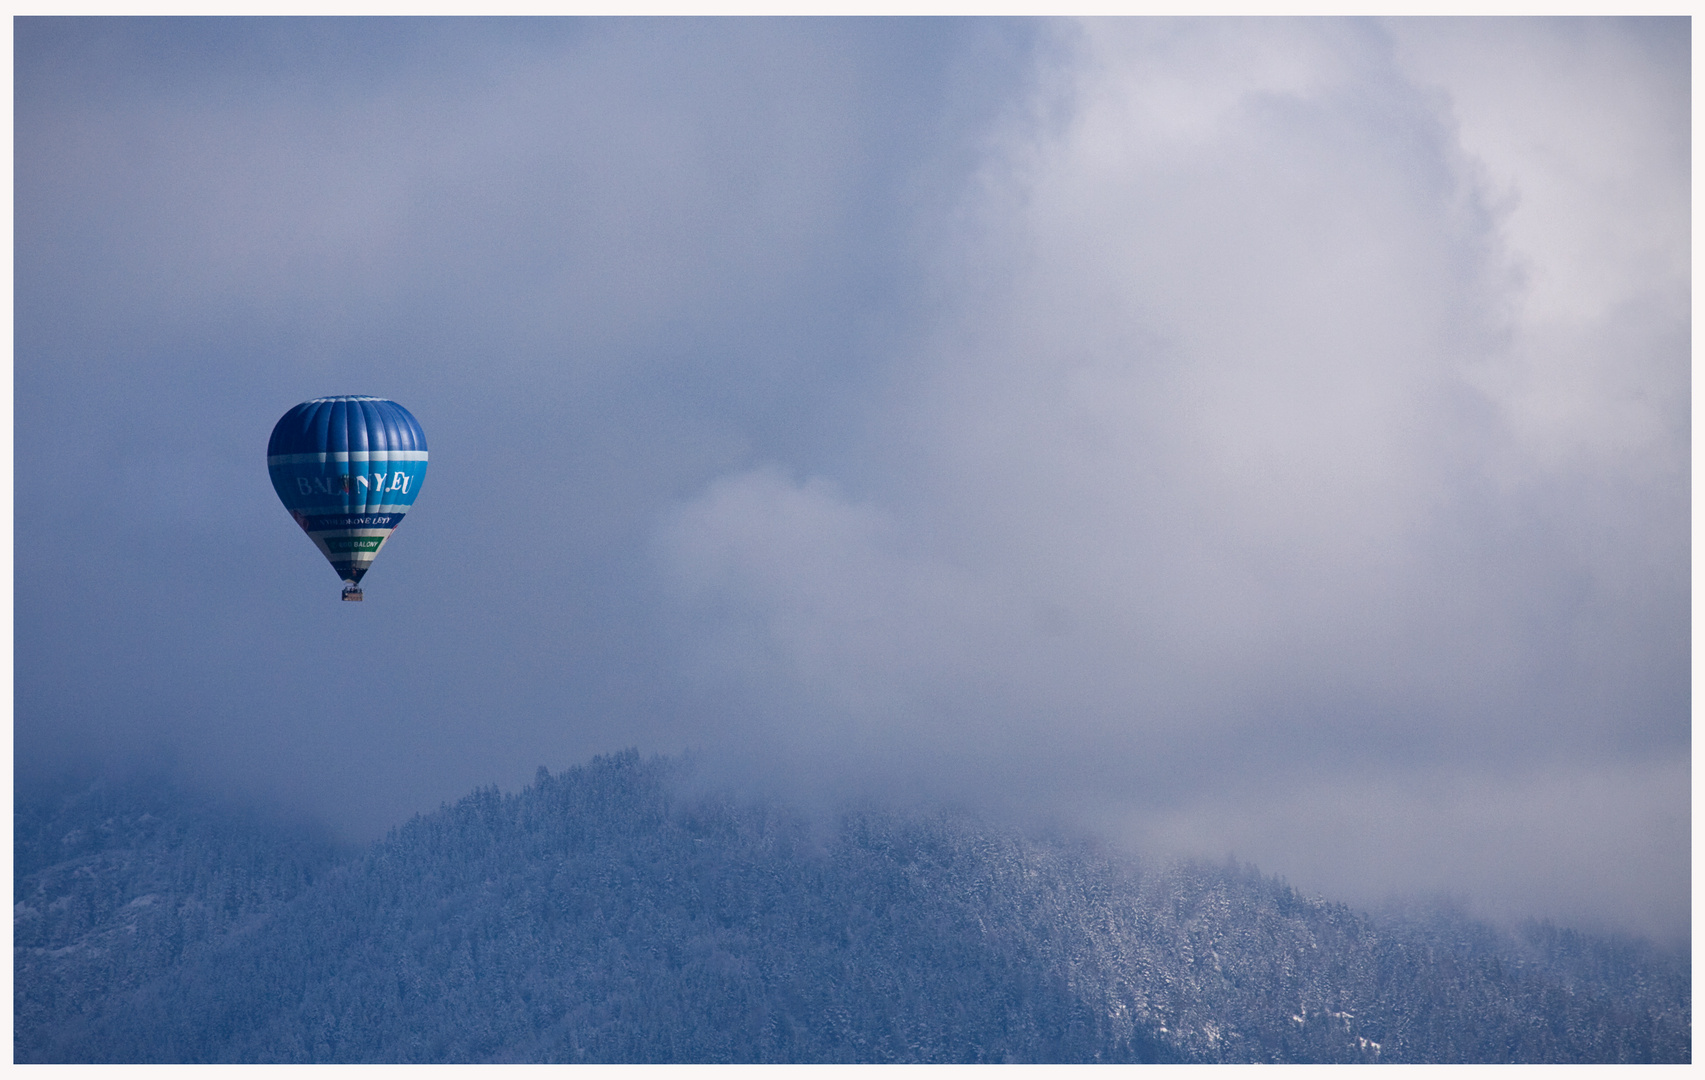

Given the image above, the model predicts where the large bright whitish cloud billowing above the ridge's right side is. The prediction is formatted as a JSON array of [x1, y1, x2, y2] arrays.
[[658, 22, 1690, 933]]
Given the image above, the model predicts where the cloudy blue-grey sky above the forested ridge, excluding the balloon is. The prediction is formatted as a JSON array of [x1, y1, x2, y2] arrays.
[[14, 19, 1690, 938]]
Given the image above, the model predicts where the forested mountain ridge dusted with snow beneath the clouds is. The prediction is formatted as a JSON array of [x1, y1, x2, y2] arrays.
[[14, 752, 1691, 1061]]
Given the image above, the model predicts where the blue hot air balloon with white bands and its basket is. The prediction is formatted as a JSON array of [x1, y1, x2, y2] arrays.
[[266, 398, 426, 601]]
